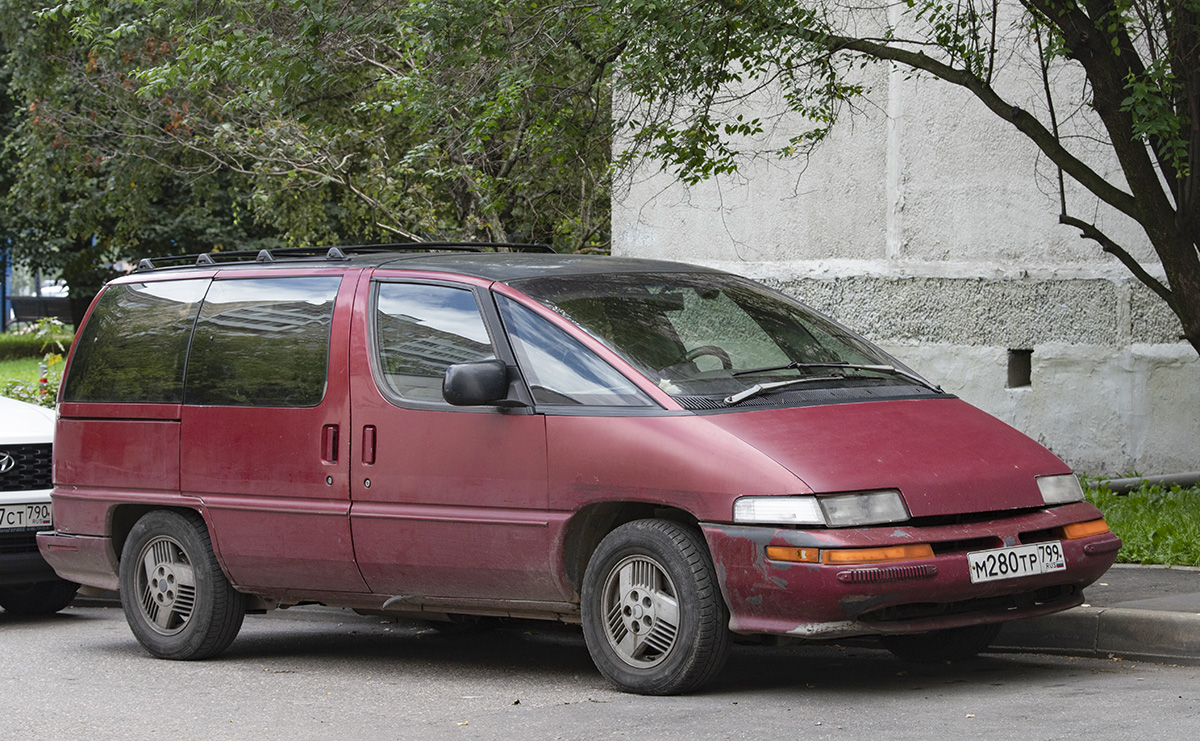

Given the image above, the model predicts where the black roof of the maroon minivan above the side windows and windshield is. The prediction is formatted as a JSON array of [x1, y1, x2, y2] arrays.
[[133, 246, 720, 283]]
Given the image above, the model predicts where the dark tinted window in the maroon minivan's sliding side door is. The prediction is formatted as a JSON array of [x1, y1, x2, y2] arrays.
[[184, 276, 341, 406]]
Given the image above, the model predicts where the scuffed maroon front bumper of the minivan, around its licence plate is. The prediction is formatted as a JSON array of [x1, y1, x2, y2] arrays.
[[701, 502, 1121, 638]]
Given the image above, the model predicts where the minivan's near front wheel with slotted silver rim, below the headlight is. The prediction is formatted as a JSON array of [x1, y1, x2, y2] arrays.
[[582, 519, 730, 694]]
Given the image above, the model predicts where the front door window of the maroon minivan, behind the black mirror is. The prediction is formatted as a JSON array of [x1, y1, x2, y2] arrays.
[[374, 283, 496, 402]]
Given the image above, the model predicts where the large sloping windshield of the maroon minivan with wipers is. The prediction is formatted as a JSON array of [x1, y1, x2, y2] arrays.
[[514, 272, 928, 405]]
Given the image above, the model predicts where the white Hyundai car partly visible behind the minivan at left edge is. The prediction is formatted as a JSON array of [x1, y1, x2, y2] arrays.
[[0, 397, 79, 615]]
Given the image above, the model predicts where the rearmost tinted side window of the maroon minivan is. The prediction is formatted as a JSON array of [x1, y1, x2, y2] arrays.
[[62, 278, 209, 404]]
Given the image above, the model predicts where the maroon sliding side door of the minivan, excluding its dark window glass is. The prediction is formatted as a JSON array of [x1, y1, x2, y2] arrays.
[[180, 270, 366, 591]]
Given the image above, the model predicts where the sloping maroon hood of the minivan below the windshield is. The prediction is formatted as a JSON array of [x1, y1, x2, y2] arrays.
[[708, 398, 1070, 517]]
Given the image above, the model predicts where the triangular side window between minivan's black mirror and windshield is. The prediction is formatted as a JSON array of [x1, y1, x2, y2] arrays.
[[498, 296, 654, 406]]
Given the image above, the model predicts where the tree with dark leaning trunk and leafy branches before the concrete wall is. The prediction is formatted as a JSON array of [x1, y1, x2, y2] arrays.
[[600, 0, 1200, 351]]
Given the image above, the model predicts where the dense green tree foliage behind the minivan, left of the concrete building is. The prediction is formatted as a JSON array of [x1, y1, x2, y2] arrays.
[[14, 0, 612, 249]]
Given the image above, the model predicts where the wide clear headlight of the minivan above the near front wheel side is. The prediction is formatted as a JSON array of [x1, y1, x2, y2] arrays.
[[733, 489, 908, 528]]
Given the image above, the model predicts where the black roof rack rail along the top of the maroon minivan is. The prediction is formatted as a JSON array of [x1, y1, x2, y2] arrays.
[[134, 242, 554, 272]]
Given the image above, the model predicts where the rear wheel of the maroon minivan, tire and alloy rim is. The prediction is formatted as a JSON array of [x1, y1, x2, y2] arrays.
[[120, 510, 246, 659]]
